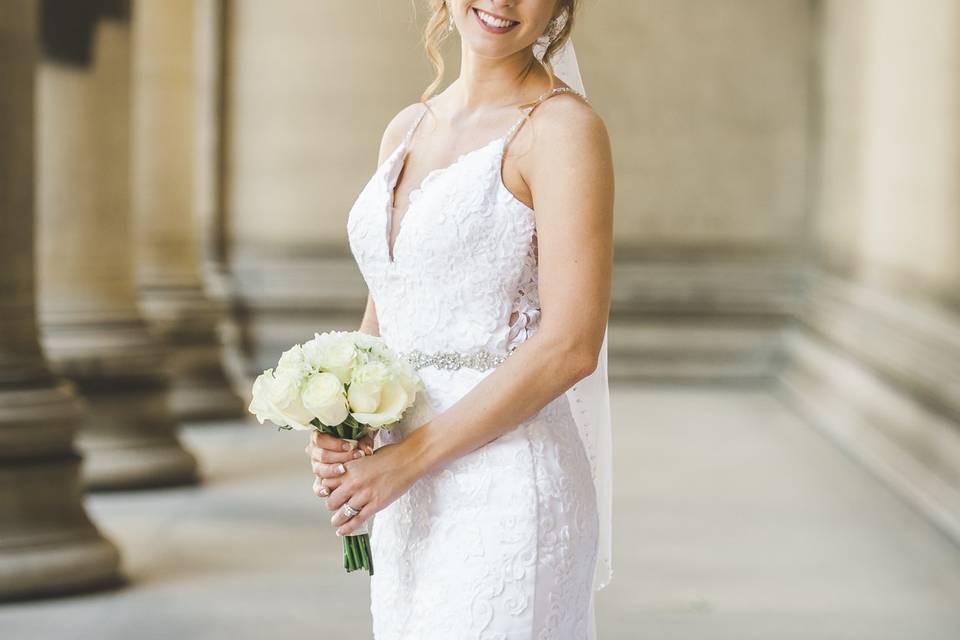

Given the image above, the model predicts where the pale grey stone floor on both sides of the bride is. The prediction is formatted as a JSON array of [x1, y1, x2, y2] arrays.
[[0, 386, 960, 640]]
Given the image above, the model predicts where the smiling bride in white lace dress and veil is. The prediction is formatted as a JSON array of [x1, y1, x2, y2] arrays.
[[306, 0, 614, 640]]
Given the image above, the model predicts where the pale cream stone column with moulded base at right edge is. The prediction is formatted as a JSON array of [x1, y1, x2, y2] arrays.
[[781, 0, 960, 542]]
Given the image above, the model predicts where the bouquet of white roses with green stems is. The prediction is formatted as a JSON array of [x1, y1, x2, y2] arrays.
[[249, 331, 423, 575]]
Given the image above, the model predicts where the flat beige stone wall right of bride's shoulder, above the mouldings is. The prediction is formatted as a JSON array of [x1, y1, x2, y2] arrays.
[[576, 0, 813, 252]]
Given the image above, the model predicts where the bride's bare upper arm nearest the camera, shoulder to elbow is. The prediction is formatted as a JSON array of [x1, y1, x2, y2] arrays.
[[521, 96, 614, 372]]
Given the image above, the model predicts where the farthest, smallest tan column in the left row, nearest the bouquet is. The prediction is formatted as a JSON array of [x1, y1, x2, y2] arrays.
[[133, 0, 244, 420]]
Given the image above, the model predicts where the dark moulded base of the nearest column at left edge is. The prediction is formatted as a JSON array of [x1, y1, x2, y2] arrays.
[[0, 381, 121, 600]]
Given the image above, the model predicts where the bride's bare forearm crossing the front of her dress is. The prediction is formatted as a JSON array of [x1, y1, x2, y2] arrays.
[[403, 333, 587, 476]]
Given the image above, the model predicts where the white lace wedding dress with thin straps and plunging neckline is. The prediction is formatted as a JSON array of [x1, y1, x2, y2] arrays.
[[347, 91, 598, 640]]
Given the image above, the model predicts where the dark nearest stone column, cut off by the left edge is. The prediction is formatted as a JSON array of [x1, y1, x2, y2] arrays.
[[0, 1, 119, 600]]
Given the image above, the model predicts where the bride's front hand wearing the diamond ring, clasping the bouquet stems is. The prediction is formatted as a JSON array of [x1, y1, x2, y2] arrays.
[[324, 442, 417, 535]]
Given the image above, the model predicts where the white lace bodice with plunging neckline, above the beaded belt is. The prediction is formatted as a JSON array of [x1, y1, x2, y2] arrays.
[[347, 90, 572, 354]]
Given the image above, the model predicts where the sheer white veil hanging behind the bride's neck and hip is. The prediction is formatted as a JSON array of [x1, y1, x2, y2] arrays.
[[533, 38, 613, 591]]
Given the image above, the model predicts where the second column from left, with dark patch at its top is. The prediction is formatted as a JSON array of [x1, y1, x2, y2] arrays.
[[37, 0, 196, 489]]
